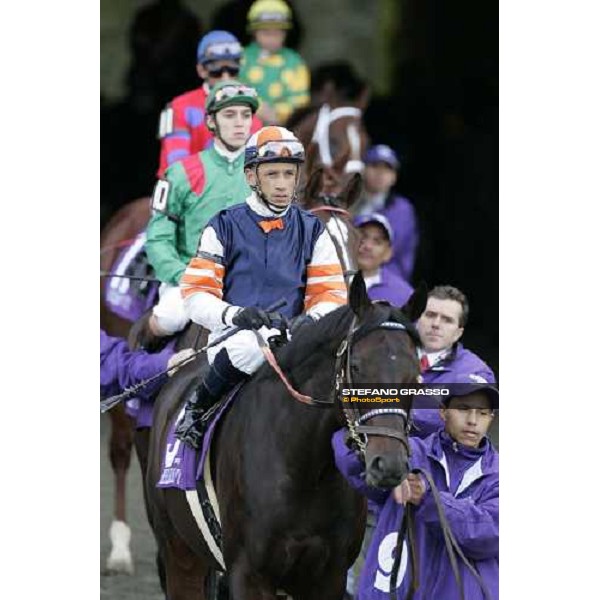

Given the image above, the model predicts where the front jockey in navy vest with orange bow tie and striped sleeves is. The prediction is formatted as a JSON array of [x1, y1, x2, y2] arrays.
[[177, 126, 347, 448]]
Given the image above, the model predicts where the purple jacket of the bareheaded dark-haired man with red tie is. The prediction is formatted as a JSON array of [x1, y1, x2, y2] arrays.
[[411, 344, 496, 438]]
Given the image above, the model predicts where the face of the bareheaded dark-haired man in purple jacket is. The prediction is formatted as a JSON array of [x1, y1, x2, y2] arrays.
[[417, 298, 464, 352]]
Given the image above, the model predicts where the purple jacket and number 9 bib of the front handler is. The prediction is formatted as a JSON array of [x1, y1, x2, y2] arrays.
[[332, 429, 499, 600]]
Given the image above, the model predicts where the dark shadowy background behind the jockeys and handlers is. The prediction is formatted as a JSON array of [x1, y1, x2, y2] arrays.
[[101, 0, 499, 372]]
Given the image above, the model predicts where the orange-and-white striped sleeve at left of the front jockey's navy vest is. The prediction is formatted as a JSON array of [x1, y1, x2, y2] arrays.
[[179, 227, 238, 331]]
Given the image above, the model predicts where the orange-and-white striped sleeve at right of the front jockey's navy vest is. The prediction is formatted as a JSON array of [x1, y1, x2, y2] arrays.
[[304, 231, 348, 319]]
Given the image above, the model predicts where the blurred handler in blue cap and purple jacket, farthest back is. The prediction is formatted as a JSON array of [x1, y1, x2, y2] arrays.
[[352, 144, 419, 281]]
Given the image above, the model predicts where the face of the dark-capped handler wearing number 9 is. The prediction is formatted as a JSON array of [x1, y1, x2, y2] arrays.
[[440, 391, 494, 448]]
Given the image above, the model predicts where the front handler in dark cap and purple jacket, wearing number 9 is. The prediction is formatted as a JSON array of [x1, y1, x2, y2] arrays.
[[332, 378, 499, 600]]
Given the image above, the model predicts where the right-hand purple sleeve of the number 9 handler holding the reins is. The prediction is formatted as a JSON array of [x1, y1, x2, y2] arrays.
[[417, 479, 499, 560]]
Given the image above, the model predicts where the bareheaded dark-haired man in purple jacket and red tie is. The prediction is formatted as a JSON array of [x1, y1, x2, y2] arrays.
[[411, 285, 496, 438]]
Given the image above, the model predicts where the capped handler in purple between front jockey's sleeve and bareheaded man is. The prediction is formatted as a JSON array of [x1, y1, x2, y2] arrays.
[[354, 213, 413, 306]]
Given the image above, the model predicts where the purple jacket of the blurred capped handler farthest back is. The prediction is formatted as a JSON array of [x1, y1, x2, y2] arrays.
[[378, 194, 419, 281]]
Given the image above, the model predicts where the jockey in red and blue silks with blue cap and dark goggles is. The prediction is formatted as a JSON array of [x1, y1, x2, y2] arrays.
[[157, 31, 262, 177]]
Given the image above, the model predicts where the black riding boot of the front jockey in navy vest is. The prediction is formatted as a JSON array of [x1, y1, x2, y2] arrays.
[[175, 348, 247, 450]]
